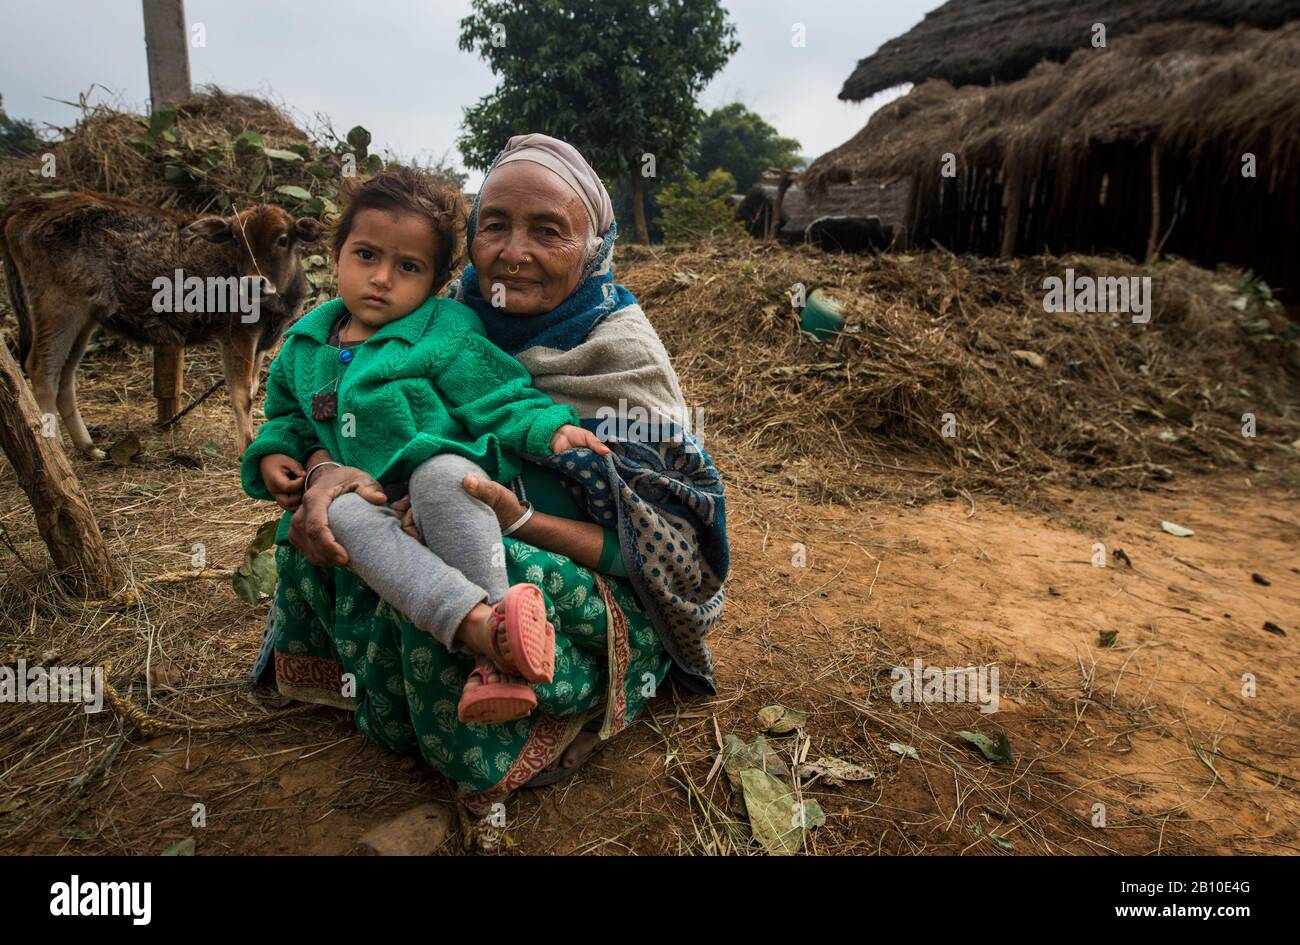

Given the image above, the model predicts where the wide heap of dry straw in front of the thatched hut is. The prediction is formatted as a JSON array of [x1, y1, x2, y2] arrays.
[[619, 240, 1300, 498]]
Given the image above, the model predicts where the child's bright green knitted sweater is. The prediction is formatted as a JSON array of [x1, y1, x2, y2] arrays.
[[241, 298, 579, 542]]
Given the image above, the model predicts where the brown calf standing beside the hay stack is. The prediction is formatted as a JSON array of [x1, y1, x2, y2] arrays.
[[0, 194, 320, 459]]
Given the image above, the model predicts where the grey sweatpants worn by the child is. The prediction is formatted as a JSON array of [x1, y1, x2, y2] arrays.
[[329, 455, 508, 653]]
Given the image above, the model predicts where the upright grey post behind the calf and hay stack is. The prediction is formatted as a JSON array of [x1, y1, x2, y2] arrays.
[[143, 0, 190, 422]]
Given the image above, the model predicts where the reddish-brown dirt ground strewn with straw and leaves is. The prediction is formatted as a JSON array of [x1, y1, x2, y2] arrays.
[[0, 324, 1300, 855]]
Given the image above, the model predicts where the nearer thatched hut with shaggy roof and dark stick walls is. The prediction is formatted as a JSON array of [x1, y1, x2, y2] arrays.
[[803, 22, 1300, 304]]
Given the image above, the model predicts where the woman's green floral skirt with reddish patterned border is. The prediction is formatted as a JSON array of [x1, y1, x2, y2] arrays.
[[273, 538, 671, 810]]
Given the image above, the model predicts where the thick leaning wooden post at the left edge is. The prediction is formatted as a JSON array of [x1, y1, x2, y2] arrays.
[[0, 342, 122, 598]]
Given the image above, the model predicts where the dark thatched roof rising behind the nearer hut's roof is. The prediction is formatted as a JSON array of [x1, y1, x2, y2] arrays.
[[840, 0, 1300, 101]]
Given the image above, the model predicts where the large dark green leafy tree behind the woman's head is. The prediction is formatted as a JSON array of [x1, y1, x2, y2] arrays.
[[458, 0, 740, 242]]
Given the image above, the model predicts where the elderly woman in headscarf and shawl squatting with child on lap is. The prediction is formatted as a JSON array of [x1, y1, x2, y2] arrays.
[[254, 134, 728, 810]]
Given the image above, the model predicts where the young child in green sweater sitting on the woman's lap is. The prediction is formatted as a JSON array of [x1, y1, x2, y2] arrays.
[[241, 169, 608, 723]]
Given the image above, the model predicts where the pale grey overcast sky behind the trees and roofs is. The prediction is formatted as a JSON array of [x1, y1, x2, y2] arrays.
[[0, 0, 941, 190]]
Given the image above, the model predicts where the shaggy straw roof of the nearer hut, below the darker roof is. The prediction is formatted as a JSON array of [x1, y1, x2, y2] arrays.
[[803, 22, 1300, 192]]
